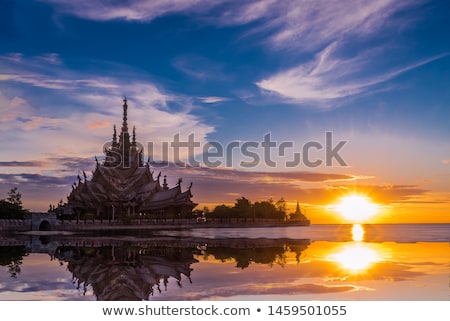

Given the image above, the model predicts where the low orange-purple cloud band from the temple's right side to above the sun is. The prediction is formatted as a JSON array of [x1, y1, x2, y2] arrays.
[[169, 167, 428, 204]]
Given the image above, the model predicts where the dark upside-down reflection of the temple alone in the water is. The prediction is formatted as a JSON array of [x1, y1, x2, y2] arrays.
[[55, 244, 197, 301]]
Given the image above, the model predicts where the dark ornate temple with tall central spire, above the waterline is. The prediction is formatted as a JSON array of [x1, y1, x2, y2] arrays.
[[67, 99, 197, 220]]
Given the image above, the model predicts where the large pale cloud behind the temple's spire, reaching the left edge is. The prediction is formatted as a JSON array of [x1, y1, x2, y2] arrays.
[[0, 54, 214, 160]]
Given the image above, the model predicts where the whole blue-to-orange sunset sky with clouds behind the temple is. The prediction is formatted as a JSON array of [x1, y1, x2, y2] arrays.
[[0, 0, 450, 223]]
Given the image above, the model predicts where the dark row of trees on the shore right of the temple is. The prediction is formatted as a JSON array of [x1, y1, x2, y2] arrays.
[[205, 197, 296, 221]]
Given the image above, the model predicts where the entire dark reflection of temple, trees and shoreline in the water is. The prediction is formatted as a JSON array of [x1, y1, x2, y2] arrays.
[[0, 237, 309, 301]]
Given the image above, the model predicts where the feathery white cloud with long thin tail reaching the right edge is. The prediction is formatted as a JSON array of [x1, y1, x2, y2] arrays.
[[256, 42, 448, 106]]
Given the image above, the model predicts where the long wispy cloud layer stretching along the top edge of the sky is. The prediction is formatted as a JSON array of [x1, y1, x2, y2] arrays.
[[41, 0, 426, 50]]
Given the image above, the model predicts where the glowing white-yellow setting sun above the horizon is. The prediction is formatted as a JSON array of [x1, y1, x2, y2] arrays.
[[334, 194, 379, 223]]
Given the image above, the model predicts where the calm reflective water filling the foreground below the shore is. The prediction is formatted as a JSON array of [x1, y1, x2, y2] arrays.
[[0, 224, 450, 300]]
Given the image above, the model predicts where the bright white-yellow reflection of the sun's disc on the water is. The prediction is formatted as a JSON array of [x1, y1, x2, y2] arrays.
[[329, 243, 381, 273]]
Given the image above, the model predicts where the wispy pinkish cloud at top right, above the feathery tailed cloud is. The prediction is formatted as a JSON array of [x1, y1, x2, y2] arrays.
[[244, 0, 423, 50]]
